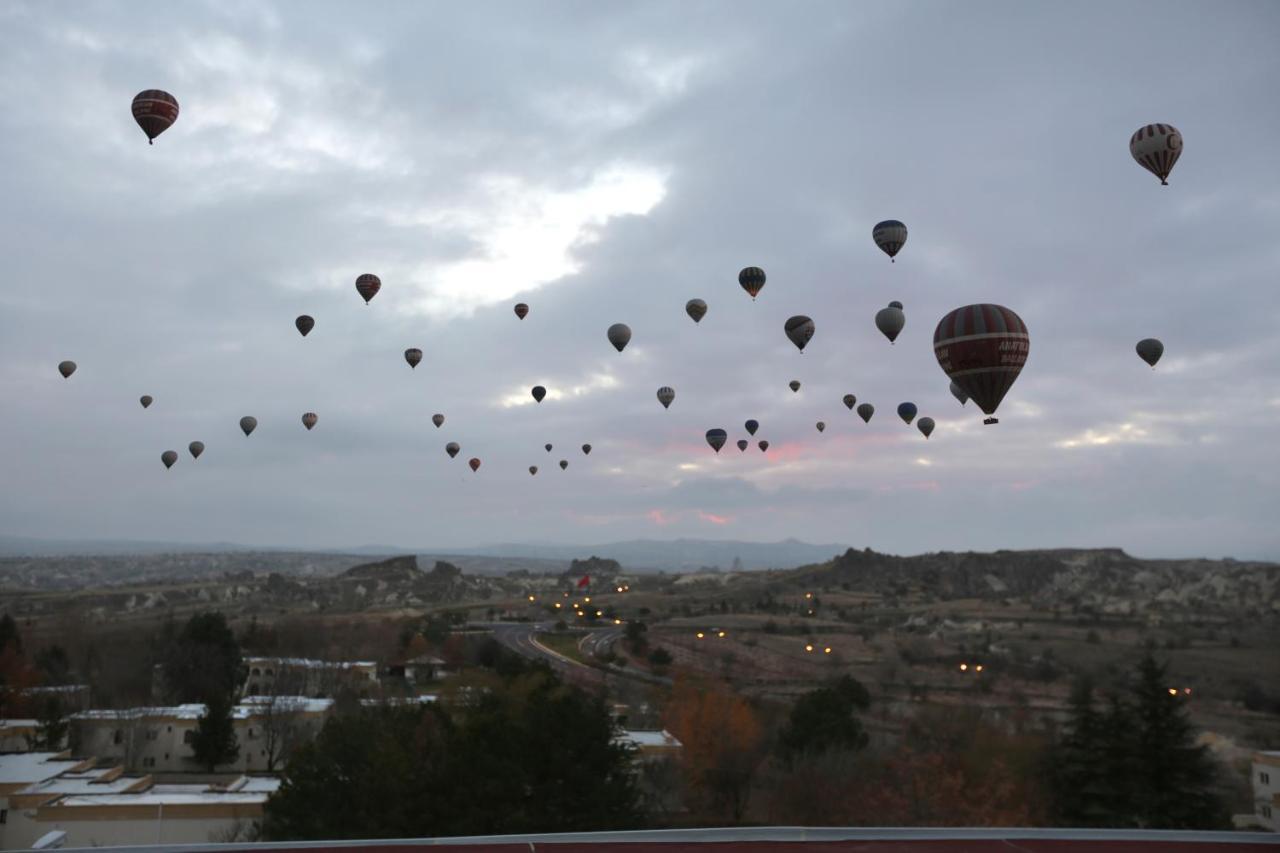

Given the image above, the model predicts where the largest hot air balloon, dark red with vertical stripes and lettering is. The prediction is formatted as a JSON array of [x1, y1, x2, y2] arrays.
[[933, 305, 1030, 424]]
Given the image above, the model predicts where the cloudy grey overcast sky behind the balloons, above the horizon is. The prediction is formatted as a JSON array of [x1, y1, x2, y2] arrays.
[[0, 0, 1280, 558]]
